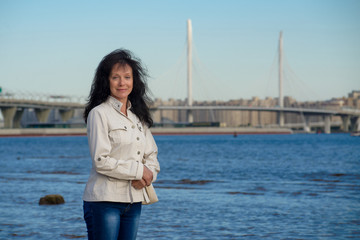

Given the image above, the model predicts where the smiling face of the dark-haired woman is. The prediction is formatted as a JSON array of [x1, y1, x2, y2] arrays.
[[109, 63, 133, 105]]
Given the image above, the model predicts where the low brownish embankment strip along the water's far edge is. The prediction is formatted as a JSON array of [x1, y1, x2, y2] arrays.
[[0, 127, 293, 137]]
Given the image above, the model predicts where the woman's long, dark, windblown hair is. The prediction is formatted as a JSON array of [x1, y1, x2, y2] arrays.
[[84, 49, 153, 127]]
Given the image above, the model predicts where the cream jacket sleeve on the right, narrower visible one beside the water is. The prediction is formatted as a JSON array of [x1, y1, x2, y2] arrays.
[[143, 126, 160, 182]]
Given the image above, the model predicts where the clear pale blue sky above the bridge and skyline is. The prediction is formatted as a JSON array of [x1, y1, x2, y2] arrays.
[[0, 0, 360, 101]]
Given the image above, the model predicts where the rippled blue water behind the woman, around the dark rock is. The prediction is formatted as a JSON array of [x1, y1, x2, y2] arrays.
[[0, 134, 360, 240]]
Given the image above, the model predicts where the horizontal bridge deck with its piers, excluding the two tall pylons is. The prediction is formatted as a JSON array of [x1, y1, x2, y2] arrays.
[[0, 95, 360, 133]]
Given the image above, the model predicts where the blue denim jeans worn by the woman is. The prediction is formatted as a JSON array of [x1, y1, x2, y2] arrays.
[[84, 201, 141, 240]]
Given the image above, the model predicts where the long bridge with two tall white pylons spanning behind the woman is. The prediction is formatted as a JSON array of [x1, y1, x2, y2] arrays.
[[0, 20, 360, 133]]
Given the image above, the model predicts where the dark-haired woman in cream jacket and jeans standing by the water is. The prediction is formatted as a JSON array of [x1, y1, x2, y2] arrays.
[[83, 49, 160, 240]]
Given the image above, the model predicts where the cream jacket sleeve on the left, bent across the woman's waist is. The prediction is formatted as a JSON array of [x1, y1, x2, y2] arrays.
[[87, 109, 144, 180]]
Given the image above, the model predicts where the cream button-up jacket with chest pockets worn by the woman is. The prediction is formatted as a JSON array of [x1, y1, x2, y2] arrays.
[[83, 96, 160, 202]]
